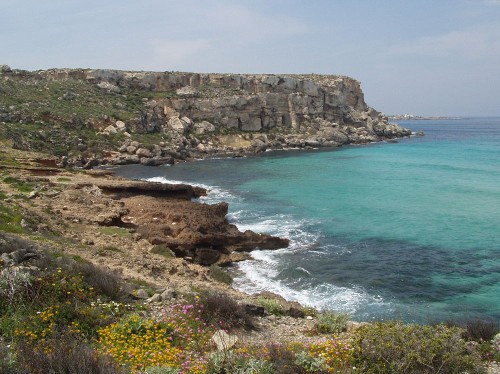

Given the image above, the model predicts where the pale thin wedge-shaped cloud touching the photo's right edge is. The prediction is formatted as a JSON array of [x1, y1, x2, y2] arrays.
[[390, 25, 500, 60]]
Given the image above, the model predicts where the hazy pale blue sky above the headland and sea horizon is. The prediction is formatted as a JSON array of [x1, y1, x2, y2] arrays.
[[0, 0, 500, 116]]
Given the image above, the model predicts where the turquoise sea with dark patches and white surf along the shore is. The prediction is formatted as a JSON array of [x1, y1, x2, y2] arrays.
[[118, 118, 500, 322]]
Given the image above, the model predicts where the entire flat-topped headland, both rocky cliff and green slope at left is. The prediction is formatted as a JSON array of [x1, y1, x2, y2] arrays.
[[0, 65, 411, 168]]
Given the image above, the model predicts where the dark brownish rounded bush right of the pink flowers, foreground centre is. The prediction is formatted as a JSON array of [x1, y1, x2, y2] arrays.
[[200, 292, 255, 329]]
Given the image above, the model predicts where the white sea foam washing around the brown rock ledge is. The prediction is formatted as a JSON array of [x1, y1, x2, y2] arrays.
[[147, 177, 388, 314]]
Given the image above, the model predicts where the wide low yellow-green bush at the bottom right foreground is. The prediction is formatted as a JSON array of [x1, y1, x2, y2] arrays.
[[352, 321, 478, 373]]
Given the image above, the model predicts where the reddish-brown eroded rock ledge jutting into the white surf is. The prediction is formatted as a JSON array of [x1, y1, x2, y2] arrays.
[[50, 178, 289, 265]]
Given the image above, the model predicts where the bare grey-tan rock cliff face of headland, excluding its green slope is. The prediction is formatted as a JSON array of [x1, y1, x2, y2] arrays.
[[0, 68, 410, 164]]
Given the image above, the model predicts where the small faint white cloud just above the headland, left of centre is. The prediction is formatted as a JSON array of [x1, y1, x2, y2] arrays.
[[150, 39, 211, 66]]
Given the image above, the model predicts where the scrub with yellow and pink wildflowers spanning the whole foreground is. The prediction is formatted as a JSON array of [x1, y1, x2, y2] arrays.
[[0, 237, 500, 374]]
